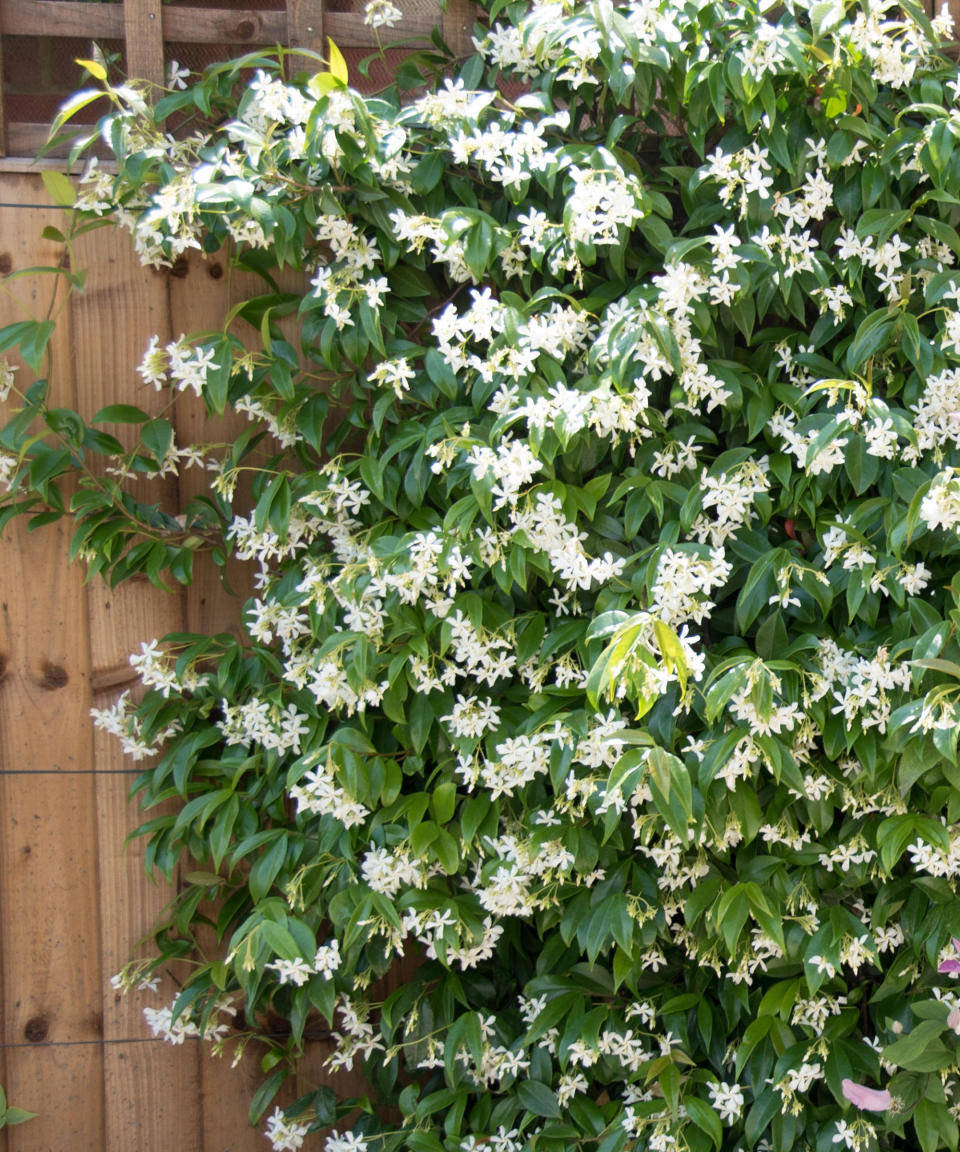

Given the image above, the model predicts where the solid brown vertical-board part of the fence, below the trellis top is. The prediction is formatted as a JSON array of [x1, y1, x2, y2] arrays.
[[0, 173, 380, 1152]]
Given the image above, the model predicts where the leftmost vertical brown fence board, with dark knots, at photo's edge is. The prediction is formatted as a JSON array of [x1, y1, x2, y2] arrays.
[[0, 176, 104, 1152]]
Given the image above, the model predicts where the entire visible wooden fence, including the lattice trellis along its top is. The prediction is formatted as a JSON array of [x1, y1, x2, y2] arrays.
[[0, 0, 470, 1152]]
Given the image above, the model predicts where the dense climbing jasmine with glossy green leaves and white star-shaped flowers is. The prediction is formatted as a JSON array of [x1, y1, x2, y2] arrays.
[[2, 0, 960, 1152]]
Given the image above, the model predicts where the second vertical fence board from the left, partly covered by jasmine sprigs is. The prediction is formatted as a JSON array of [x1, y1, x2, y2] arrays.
[[73, 214, 206, 1152]]
